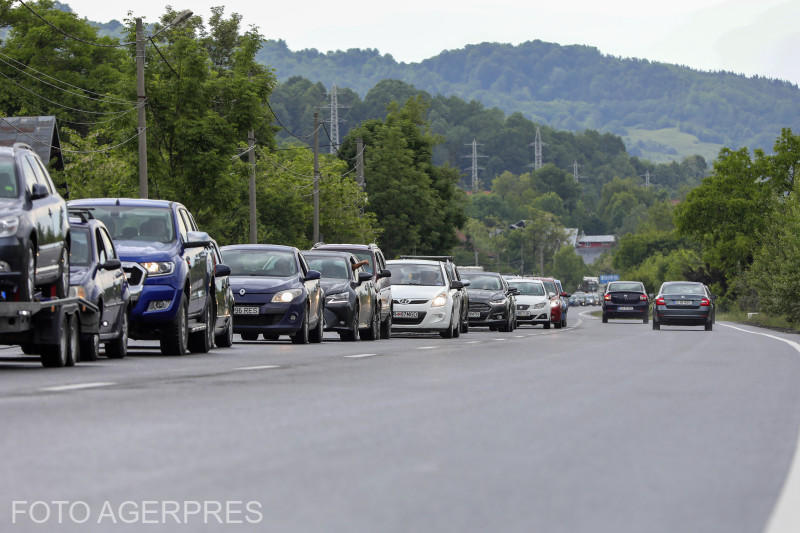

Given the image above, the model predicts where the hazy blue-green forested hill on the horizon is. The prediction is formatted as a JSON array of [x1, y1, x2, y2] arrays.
[[258, 40, 800, 162]]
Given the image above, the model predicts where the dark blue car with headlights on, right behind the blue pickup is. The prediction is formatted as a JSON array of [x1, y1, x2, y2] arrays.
[[221, 244, 323, 344]]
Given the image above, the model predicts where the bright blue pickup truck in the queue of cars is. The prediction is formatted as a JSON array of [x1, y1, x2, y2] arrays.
[[69, 198, 219, 355]]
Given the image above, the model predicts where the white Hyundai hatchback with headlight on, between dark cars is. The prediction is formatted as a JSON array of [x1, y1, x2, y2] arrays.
[[386, 259, 462, 338]]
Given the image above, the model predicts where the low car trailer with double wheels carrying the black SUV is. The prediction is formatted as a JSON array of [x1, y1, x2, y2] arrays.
[[0, 293, 99, 367]]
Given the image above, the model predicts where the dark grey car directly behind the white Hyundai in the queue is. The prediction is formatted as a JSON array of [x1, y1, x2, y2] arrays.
[[461, 272, 519, 331]]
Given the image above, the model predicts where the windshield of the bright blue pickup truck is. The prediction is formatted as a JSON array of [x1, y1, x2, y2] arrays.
[[86, 205, 175, 243]]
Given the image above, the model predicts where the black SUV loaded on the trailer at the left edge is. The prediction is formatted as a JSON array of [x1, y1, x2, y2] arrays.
[[0, 143, 70, 302]]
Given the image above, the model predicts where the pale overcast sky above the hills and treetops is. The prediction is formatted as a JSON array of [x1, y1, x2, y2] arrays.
[[62, 0, 800, 84]]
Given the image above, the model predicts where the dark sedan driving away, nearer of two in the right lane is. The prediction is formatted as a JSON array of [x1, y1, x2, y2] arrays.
[[653, 281, 716, 331]]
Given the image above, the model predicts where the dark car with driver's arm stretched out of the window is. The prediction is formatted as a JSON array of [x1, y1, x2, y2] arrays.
[[303, 250, 380, 341]]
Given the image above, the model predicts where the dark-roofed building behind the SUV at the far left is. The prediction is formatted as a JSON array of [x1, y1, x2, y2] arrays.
[[0, 116, 64, 170]]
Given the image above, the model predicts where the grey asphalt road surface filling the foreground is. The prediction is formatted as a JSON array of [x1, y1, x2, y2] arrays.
[[0, 309, 800, 533]]
